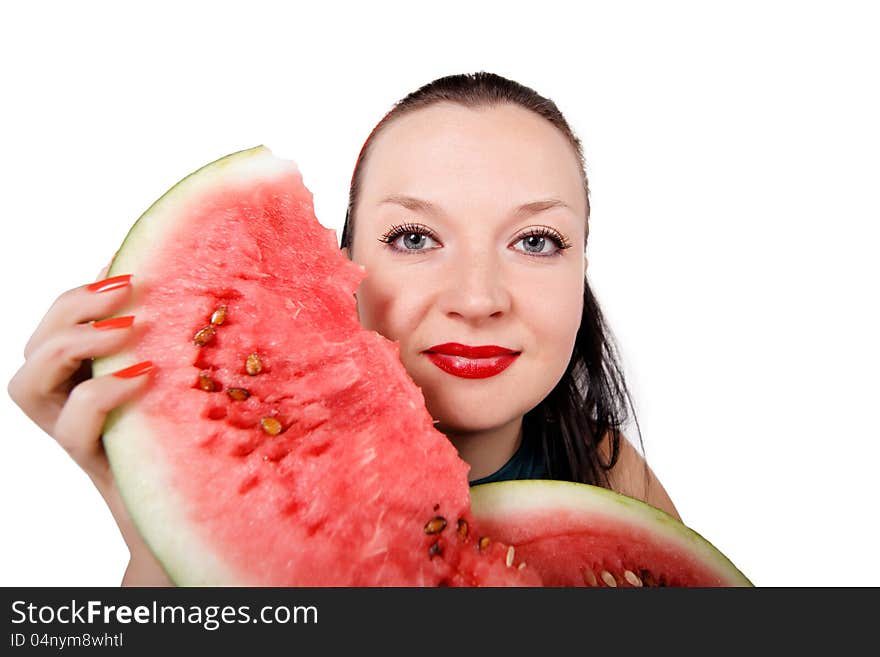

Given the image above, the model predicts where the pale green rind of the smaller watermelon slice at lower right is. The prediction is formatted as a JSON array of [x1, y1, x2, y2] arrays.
[[471, 479, 753, 587]]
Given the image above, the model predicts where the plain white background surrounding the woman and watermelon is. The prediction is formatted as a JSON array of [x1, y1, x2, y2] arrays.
[[0, 0, 880, 586]]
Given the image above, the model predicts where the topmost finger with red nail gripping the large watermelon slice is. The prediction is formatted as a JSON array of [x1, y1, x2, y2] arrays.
[[24, 276, 131, 359]]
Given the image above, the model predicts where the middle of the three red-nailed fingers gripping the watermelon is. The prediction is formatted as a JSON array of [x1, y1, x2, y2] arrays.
[[15, 316, 139, 404]]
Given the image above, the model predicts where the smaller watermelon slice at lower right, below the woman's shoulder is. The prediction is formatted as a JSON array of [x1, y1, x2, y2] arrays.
[[471, 481, 751, 587]]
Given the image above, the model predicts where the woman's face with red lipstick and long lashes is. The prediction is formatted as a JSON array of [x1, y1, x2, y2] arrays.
[[351, 103, 587, 433]]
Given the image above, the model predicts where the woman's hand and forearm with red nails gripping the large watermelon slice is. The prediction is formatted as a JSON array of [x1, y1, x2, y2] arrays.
[[8, 269, 171, 586]]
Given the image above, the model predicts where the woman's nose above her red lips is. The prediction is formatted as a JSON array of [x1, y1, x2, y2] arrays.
[[440, 253, 511, 322]]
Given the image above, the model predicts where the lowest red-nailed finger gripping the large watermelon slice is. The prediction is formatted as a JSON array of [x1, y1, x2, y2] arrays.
[[53, 367, 151, 486]]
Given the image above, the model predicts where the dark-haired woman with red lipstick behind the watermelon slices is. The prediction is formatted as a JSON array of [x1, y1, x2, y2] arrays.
[[9, 73, 678, 586]]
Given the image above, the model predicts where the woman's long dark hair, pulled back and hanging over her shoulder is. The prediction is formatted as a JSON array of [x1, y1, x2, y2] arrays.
[[340, 72, 641, 488]]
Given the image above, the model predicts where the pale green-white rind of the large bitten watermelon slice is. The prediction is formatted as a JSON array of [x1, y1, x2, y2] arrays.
[[92, 145, 299, 586]]
